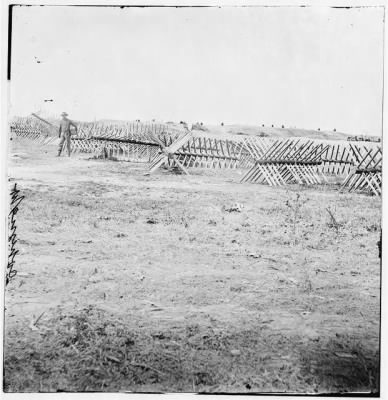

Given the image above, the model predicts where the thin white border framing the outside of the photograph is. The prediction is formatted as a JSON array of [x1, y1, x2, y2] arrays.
[[0, 0, 388, 400]]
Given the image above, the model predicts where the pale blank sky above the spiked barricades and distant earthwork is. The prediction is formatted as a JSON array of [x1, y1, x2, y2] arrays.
[[9, 6, 383, 135]]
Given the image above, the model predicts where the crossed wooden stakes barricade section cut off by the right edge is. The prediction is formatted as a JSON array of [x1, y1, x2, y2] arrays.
[[341, 144, 383, 196]]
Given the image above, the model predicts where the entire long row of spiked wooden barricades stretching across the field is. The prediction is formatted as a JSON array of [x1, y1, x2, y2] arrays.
[[11, 114, 382, 195]]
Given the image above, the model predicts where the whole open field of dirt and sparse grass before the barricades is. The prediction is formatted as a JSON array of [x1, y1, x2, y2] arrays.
[[4, 139, 381, 393]]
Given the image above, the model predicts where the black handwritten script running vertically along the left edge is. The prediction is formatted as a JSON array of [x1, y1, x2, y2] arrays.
[[5, 182, 24, 286]]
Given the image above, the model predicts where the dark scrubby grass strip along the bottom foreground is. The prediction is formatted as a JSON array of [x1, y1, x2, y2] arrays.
[[4, 307, 378, 393]]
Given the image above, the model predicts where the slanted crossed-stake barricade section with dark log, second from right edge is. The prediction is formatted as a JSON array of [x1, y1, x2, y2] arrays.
[[241, 139, 329, 186]]
